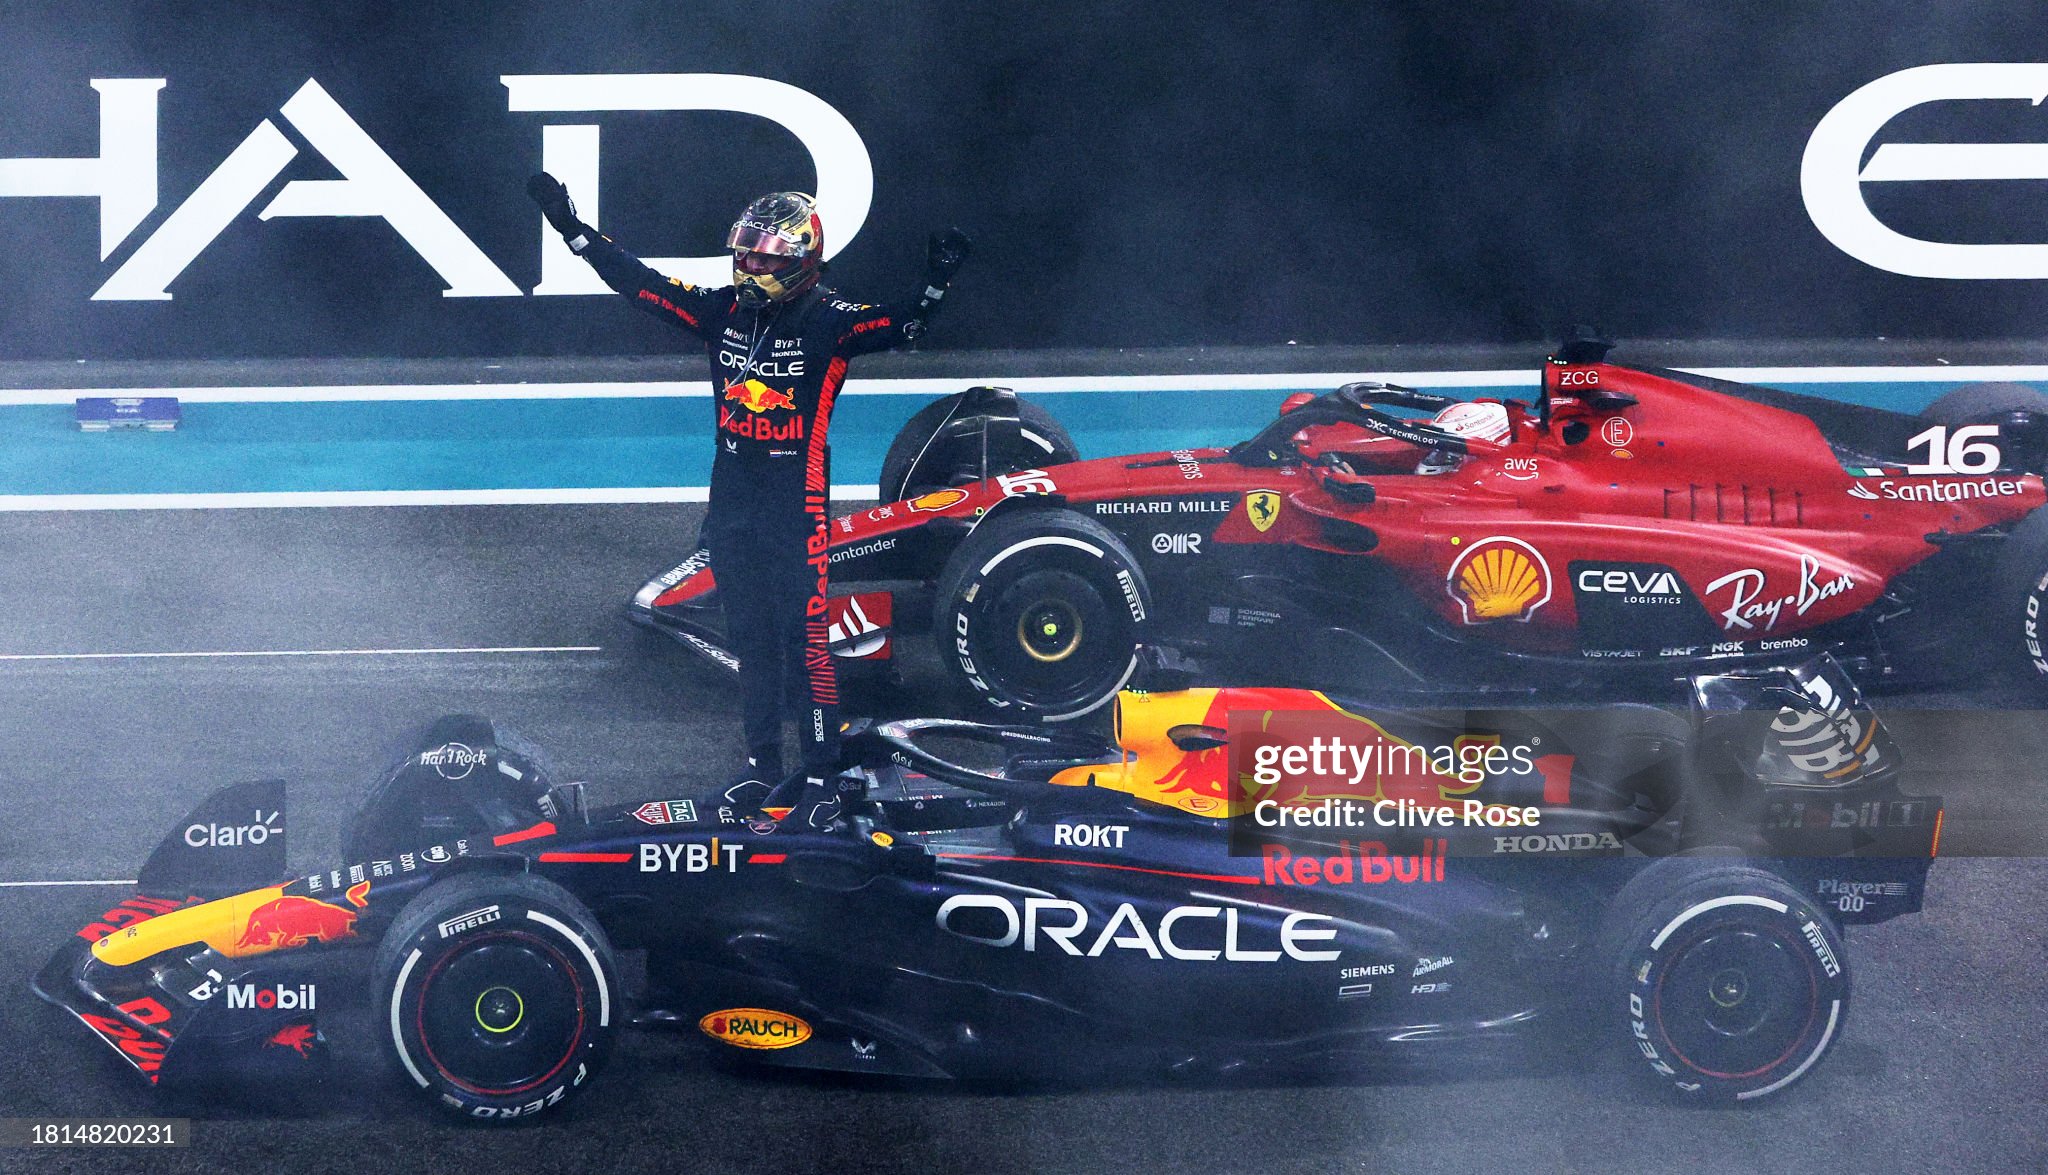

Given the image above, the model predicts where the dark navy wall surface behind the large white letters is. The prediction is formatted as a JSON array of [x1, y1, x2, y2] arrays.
[[0, 0, 2048, 360]]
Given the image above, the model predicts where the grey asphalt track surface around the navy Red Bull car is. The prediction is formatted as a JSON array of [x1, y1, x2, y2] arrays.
[[0, 506, 2048, 1173]]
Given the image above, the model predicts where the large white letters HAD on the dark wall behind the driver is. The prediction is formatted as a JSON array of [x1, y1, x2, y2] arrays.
[[0, 74, 874, 301]]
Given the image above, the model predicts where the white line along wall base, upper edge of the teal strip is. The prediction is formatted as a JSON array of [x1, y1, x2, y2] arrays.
[[0, 364, 2048, 405]]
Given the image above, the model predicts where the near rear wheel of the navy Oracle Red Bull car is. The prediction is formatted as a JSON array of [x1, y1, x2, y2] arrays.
[[1589, 858, 1849, 1103]]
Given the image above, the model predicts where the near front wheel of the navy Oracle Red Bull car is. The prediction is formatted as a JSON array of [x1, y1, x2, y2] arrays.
[[373, 874, 625, 1122]]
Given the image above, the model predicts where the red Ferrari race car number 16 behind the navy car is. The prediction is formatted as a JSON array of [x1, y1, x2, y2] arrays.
[[629, 338, 2048, 721]]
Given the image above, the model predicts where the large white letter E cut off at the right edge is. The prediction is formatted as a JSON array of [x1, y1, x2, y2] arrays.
[[1798, 61, 2048, 280]]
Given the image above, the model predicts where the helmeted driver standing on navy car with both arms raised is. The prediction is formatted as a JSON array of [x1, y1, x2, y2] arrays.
[[526, 172, 969, 827]]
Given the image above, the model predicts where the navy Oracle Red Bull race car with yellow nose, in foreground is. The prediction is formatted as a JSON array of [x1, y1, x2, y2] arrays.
[[35, 659, 1942, 1122]]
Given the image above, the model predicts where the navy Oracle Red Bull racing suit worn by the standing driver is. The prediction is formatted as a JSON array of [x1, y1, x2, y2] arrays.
[[569, 233, 944, 782]]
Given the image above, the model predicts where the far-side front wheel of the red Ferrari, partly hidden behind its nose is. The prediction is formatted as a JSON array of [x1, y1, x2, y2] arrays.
[[881, 389, 1081, 502]]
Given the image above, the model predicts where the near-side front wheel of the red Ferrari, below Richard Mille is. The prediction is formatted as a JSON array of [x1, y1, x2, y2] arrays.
[[932, 508, 1153, 723]]
